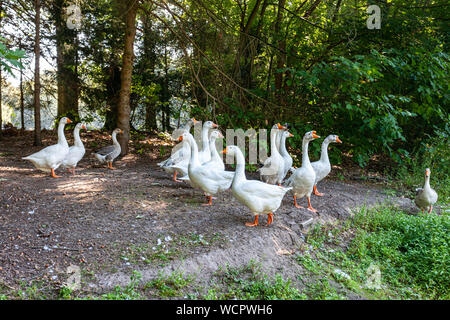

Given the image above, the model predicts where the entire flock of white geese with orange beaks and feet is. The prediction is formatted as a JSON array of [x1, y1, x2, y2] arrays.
[[22, 117, 437, 227]]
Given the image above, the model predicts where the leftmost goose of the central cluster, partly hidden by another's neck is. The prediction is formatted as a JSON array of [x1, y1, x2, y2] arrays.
[[158, 118, 198, 182]]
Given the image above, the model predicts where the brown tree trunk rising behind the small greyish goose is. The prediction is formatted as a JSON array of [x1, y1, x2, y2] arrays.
[[117, 0, 138, 155]]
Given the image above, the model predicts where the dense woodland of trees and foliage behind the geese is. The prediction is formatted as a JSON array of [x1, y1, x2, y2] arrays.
[[0, 0, 449, 167]]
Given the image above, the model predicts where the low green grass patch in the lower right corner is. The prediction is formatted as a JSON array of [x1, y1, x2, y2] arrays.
[[297, 207, 450, 299]]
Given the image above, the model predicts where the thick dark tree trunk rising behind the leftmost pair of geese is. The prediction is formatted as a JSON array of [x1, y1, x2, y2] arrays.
[[53, 0, 80, 120]]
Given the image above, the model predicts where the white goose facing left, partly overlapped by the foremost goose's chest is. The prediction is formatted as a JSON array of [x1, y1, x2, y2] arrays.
[[179, 132, 234, 205]]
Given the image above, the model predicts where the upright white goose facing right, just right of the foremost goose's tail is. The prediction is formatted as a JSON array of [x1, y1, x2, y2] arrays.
[[286, 131, 320, 212]]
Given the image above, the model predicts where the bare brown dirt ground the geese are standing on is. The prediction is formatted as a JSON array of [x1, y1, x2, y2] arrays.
[[0, 131, 426, 299]]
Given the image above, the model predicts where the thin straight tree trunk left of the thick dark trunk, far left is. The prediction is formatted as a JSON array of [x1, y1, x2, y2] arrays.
[[34, 0, 42, 146]]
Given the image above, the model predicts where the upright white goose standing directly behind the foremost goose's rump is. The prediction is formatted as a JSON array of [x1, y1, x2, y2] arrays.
[[258, 123, 286, 185]]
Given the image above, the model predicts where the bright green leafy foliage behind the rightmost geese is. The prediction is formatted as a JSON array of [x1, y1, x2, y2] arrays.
[[289, 47, 450, 166]]
